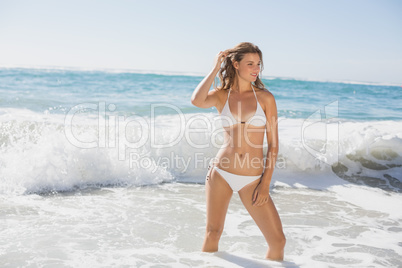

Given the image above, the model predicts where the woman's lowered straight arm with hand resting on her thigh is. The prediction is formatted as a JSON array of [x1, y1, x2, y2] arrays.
[[253, 92, 279, 206]]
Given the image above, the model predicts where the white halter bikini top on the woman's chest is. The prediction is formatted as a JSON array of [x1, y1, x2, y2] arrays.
[[220, 86, 267, 127]]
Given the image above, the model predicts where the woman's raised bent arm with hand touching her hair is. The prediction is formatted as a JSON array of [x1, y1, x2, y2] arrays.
[[191, 51, 226, 108]]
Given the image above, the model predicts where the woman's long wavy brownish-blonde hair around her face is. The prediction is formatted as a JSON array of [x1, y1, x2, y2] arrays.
[[217, 42, 265, 90]]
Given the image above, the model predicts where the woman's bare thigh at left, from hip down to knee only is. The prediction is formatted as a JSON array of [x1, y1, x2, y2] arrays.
[[205, 167, 233, 229]]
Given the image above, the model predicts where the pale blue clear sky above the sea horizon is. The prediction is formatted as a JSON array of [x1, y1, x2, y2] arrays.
[[0, 0, 402, 85]]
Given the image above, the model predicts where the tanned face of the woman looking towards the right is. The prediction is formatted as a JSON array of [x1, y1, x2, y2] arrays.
[[234, 53, 261, 82]]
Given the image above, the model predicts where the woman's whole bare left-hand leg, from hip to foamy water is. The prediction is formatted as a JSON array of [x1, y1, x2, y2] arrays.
[[202, 167, 233, 252]]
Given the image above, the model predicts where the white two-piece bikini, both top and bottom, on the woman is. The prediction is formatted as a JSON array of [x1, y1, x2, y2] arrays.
[[207, 86, 267, 192]]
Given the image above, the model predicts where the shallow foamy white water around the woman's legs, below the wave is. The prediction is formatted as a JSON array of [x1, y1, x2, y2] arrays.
[[0, 182, 402, 267]]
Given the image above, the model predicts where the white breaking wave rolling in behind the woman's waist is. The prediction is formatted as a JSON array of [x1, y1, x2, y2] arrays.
[[0, 109, 402, 193]]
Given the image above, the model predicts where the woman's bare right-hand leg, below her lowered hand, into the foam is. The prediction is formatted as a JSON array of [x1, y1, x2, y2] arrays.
[[239, 180, 286, 260]]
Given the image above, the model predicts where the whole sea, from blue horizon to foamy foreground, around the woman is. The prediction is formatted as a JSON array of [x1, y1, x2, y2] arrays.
[[0, 67, 402, 267]]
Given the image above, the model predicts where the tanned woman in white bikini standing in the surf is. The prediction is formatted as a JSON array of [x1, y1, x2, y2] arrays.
[[191, 42, 286, 260]]
